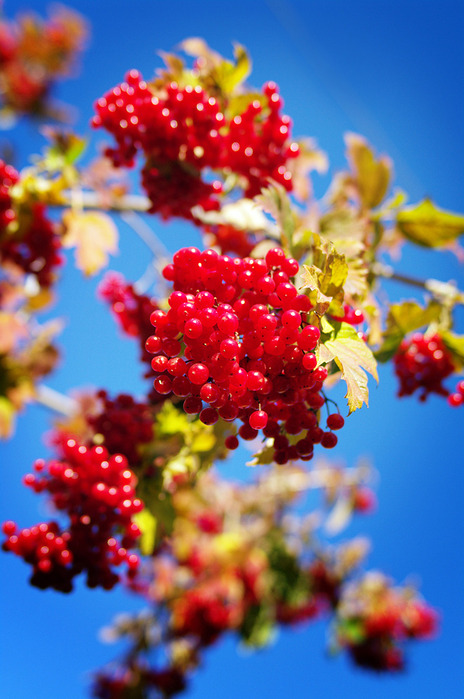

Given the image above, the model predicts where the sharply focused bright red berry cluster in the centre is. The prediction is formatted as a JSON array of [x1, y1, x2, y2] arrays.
[[146, 248, 344, 464]]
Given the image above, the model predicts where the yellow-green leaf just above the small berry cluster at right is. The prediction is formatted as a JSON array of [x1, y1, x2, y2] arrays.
[[375, 301, 442, 362]]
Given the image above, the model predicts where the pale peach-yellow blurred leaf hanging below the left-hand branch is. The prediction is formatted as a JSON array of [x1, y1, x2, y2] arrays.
[[63, 210, 118, 275]]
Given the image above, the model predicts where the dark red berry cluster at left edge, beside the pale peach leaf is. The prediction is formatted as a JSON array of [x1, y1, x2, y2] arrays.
[[0, 160, 62, 287]]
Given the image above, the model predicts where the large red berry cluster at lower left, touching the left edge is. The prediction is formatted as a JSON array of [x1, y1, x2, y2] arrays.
[[3, 439, 143, 592]]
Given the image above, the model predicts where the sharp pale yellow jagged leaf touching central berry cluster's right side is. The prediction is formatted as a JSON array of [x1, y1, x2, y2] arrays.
[[317, 322, 379, 413]]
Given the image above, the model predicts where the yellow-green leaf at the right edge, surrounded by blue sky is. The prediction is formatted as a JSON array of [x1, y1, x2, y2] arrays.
[[396, 199, 464, 248]]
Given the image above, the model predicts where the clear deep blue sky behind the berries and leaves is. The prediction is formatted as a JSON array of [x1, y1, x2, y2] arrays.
[[0, 0, 464, 699]]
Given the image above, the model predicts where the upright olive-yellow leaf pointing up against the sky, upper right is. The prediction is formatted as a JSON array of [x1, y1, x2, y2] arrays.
[[345, 133, 392, 209]]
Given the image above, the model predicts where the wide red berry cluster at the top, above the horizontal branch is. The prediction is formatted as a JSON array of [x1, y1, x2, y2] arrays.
[[92, 70, 299, 220]]
